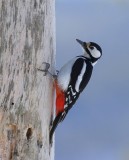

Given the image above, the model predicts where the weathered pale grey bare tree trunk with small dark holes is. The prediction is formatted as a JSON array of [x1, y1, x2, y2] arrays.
[[0, 0, 55, 160]]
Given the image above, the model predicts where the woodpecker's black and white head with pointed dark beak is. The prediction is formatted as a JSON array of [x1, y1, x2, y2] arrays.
[[76, 39, 102, 63]]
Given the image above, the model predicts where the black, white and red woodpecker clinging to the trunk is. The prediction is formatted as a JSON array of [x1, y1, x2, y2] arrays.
[[42, 39, 102, 143]]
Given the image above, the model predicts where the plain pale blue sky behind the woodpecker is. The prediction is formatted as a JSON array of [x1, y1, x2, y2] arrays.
[[56, 0, 129, 160]]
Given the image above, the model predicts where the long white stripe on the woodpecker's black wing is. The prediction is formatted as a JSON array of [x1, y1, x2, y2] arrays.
[[75, 62, 86, 92]]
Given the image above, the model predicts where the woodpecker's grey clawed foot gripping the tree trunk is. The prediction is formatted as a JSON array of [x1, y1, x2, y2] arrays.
[[37, 62, 57, 80]]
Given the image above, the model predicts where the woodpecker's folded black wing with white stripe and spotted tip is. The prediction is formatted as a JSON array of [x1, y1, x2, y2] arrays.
[[62, 56, 93, 120]]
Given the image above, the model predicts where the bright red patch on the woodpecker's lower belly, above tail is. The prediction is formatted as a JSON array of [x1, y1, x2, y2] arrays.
[[55, 81, 65, 115]]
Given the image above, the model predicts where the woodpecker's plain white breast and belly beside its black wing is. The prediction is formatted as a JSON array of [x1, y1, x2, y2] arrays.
[[57, 58, 77, 91]]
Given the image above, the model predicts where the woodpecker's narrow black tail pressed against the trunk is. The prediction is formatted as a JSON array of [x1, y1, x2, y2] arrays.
[[49, 113, 62, 144]]
